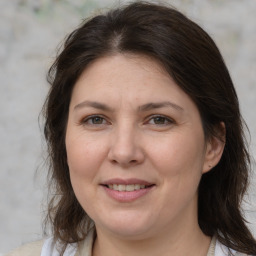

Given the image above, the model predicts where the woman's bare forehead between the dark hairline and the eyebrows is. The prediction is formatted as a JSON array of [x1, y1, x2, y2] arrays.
[[71, 54, 198, 113]]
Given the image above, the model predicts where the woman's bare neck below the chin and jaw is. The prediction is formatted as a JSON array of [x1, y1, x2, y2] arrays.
[[92, 197, 211, 256]]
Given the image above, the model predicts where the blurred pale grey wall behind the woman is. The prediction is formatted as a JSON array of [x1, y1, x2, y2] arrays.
[[0, 0, 256, 255]]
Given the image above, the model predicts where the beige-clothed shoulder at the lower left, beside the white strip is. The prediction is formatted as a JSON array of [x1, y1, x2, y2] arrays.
[[5, 240, 44, 256]]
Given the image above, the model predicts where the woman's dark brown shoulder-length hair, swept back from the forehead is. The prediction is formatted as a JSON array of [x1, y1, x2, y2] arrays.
[[44, 2, 256, 254]]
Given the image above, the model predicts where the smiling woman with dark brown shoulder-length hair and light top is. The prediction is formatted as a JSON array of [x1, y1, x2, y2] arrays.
[[5, 2, 256, 256]]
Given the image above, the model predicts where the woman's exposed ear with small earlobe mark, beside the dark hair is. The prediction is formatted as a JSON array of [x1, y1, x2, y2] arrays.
[[203, 122, 226, 173]]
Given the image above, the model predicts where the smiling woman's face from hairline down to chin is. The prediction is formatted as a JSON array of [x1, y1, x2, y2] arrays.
[[66, 54, 219, 239]]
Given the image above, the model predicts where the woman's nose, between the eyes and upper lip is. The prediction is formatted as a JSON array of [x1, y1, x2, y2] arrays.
[[108, 124, 145, 168]]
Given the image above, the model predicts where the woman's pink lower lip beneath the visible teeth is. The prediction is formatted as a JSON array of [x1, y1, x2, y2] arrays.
[[103, 186, 154, 202]]
